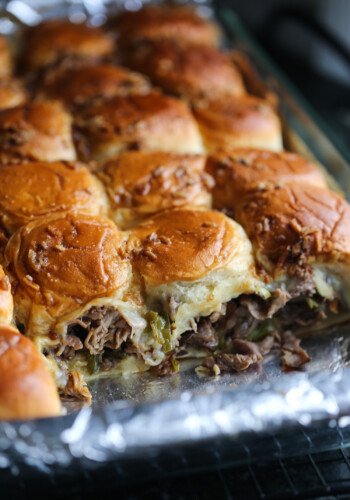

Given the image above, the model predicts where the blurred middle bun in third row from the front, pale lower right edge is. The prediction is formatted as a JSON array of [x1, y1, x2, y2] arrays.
[[75, 92, 203, 161]]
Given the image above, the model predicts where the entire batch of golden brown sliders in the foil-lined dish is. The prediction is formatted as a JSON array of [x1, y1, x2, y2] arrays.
[[0, 6, 350, 418]]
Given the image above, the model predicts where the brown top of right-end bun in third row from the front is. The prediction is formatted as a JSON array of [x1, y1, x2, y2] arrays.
[[194, 95, 279, 134]]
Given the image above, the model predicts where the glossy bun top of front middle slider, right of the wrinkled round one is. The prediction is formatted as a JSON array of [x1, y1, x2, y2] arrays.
[[133, 208, 240, 286]]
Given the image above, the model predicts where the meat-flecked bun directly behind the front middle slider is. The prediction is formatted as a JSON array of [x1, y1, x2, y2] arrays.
[[99, 151, 212, 228]]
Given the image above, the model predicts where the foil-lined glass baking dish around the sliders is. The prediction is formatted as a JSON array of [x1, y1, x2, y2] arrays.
[[0, 1, 350, 481]]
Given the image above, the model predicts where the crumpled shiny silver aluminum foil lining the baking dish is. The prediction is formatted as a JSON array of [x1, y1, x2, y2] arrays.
[[0, 0, 350, 474]]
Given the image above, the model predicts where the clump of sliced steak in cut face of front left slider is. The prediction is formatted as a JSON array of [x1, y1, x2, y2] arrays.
[[67, 306, 131, 355]]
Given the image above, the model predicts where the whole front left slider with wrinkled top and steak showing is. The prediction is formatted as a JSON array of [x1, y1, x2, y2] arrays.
[[5, 213, 145, 399]]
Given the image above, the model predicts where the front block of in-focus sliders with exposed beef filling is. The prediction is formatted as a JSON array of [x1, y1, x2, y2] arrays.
[[0, 149, 350, 399]]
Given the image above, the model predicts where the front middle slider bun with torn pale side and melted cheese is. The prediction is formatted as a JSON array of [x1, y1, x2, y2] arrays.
[[132, 208, 264, 348]]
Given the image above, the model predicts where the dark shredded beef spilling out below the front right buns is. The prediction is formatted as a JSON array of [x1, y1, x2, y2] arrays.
[[178, 277, 337, 374]]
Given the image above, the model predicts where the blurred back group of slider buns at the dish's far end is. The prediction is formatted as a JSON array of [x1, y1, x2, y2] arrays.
[[0, 8, 282, 163]]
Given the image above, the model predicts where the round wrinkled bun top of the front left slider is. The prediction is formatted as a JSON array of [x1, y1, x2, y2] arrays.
[[5, 214, 130, 314]]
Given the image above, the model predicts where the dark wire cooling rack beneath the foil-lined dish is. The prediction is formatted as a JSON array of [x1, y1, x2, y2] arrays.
[[0, 425, 350, 500]]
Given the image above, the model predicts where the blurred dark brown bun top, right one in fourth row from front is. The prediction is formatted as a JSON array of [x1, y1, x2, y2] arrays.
[[125, 40, 245, 99]]
